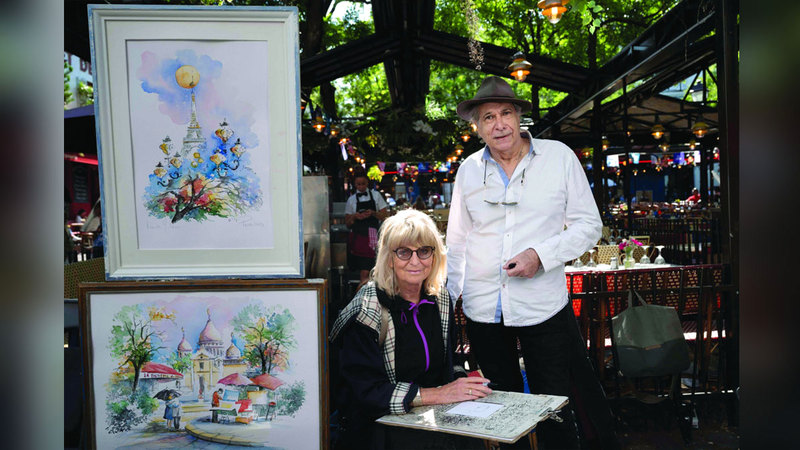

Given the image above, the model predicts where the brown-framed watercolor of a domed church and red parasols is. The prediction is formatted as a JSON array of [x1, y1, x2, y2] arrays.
[[79, 280, 329, 449]]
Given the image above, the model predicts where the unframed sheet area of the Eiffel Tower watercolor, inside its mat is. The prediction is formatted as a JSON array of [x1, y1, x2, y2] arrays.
[[128, 41, 273, 249]]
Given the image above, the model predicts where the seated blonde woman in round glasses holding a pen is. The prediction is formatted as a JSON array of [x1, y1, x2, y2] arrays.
[[330, 209, 491, 449]]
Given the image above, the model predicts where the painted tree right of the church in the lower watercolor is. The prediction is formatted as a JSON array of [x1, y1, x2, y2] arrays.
[[231, 304, 296, 374]]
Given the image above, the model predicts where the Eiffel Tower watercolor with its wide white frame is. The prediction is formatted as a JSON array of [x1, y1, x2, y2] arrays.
[[88, 5, 304, 280]]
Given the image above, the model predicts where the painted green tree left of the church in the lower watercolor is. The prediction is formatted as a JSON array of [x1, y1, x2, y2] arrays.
[[109, 305, 175, 393]]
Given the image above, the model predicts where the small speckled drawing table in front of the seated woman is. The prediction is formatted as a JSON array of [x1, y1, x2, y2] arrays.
[[376, 390, 569, 450]]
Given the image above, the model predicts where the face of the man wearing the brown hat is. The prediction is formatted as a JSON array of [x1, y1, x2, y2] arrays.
[[477, 103, 522, 152]]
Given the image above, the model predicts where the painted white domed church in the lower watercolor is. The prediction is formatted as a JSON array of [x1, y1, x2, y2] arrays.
[[177, 309, 247, 399]]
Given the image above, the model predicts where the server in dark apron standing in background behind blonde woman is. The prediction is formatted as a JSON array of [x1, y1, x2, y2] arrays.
[[344, 171, 389, 284]]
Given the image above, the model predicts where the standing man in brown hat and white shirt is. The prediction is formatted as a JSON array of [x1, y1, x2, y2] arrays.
[[447, 77, 618, 448]]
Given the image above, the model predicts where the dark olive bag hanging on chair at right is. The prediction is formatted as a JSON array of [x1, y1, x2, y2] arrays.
[[611, 289, 690, 377]]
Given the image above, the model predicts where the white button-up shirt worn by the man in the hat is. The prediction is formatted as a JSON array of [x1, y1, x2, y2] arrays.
[[447, 132, 603, 326]]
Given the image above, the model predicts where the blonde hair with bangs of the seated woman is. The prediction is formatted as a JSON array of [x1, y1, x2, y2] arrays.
[[370, 209, 447, 295]]
